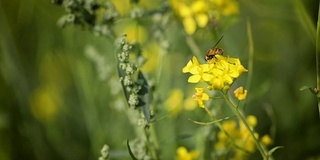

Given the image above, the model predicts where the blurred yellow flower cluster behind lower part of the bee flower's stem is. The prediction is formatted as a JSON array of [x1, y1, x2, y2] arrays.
[[215, 115, 272, 160]]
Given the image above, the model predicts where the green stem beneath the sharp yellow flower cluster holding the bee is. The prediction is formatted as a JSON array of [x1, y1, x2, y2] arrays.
[[223, 94, 268, 160]]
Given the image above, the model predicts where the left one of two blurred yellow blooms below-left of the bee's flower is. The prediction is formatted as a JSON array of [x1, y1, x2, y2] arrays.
[[165, 89, 183, 116]]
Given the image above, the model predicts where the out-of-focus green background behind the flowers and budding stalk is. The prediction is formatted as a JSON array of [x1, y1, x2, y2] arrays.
[[0, 0, 320, 160]]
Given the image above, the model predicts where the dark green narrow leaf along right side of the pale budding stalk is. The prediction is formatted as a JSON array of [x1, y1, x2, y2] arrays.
[[137, 71, 151, 122]]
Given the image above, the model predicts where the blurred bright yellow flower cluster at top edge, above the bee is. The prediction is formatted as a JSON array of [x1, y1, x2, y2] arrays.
[[170, 0, 239, 35]]
